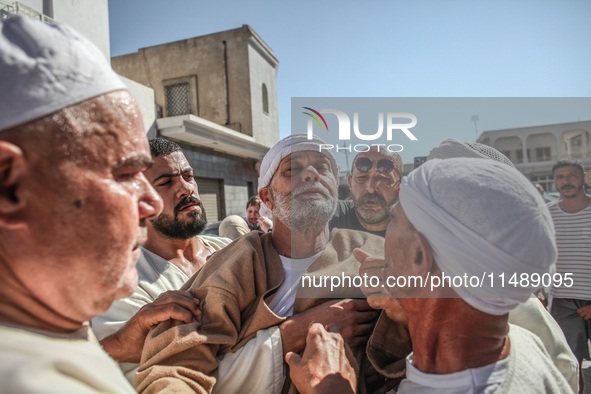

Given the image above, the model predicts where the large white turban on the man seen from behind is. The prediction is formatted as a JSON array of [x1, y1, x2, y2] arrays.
[[400, 158, 557, 315]]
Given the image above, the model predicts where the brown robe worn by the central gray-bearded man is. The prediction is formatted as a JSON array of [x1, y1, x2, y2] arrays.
[[136, 229, 394, 393]]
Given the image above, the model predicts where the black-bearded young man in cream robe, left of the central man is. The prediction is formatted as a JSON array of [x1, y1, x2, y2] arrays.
[[92, 138, 231, 384]]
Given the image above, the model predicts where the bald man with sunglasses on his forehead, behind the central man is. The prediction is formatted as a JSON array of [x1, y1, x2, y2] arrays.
[[330, 146, 403, 237]]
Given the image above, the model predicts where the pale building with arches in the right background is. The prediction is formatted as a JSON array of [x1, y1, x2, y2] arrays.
[[477, 121, 591, 192]]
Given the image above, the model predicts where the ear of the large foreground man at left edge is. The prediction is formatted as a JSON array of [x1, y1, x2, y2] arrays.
[[0, 141, 27, 228]]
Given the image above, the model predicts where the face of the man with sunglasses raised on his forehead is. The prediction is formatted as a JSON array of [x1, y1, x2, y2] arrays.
[[349, 151, 400, 224]]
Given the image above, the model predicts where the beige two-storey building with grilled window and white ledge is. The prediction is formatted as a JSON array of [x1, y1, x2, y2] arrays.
[[111, 25, 279, 221]]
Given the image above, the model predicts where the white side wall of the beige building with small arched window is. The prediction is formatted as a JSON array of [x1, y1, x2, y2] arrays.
[[245, 38, 279, 149]]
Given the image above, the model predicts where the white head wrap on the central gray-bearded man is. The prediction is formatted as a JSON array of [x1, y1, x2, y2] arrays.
[[257, 133, 339, 216]]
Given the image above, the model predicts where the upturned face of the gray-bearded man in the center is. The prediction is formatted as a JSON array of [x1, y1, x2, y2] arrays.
[[271, 151, 337, 231]]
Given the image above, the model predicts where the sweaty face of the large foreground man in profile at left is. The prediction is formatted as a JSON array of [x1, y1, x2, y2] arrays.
[[18, 91, 162, 322]]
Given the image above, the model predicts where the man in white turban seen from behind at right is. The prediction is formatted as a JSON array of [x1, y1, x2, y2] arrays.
[[290, 158, 571, 393]]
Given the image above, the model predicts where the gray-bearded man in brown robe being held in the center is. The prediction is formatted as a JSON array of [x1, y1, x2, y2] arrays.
[[136, 134, 383, 393]]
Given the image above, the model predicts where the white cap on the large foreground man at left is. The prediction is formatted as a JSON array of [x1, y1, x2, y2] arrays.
[[0, 16, 126, 131]]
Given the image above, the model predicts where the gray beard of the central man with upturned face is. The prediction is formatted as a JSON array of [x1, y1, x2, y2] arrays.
[[271, 183, 337, 232]]
